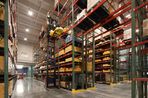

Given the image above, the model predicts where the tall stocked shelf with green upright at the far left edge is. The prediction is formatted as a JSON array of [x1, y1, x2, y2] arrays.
[[0, 0, 17, 98]]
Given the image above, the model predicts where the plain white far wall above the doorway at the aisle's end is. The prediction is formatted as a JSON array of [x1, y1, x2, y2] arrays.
[[17, 43, 33, 63]]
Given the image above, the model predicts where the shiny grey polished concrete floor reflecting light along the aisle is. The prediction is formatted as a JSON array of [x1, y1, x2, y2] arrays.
[[12, 78, 130, 98]]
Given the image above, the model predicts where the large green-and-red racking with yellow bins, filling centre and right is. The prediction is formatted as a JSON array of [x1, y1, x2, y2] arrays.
[[38, 0, 147, 95]]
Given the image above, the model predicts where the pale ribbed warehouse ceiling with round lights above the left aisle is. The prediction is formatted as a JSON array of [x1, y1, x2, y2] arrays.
[[16, 0, 54, 44]]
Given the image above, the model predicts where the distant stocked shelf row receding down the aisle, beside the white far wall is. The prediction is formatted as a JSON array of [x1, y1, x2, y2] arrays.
[[34, 29, 48, 83]]
